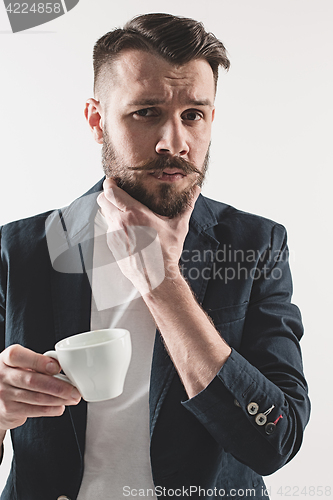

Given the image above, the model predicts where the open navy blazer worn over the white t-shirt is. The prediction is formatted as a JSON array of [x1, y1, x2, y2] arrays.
[[0, 182, 310, 500]]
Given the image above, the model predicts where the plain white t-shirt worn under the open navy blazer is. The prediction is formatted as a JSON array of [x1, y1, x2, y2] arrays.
[[78, 212, 156, 500]]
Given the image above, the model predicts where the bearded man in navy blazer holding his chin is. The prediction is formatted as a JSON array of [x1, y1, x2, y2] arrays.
[[0, 14, 309, 500]]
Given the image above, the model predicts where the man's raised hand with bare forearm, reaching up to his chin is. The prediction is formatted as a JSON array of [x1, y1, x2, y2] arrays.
[[97, 179, 231, 397]]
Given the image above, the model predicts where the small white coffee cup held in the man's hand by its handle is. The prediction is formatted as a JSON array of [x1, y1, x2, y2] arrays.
[[44, 328, 132, 402]]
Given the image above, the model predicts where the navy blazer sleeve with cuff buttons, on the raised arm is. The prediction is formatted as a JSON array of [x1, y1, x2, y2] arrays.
[[182, 225, 310, 475]]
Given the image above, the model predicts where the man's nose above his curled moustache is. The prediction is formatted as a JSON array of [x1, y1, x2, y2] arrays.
[[155, 119, 189, 156]]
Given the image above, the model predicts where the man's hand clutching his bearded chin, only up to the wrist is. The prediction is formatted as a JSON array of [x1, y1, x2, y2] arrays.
[[97, 179, 200, 295]]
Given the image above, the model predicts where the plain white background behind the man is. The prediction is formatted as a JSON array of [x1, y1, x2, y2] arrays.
[[0, 0, 333, 500]]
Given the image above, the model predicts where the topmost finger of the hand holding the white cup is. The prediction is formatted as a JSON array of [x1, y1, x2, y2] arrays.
[[2, 344, 61, 375]]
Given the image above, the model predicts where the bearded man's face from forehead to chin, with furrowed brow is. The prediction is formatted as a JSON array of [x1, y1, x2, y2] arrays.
[[97, 50, 215, 217]]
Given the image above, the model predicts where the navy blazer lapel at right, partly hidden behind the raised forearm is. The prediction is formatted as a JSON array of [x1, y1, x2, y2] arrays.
[[149, 195, 219, 436]]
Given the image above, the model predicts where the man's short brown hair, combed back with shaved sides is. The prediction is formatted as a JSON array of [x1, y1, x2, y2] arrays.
[[93, 14, 230, 96]]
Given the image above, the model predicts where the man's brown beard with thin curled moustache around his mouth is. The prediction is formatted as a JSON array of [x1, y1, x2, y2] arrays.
[[102, 130, 209, 219]]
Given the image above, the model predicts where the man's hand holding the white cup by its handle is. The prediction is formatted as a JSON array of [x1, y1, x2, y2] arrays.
[[0, 345, 81, 435]]
